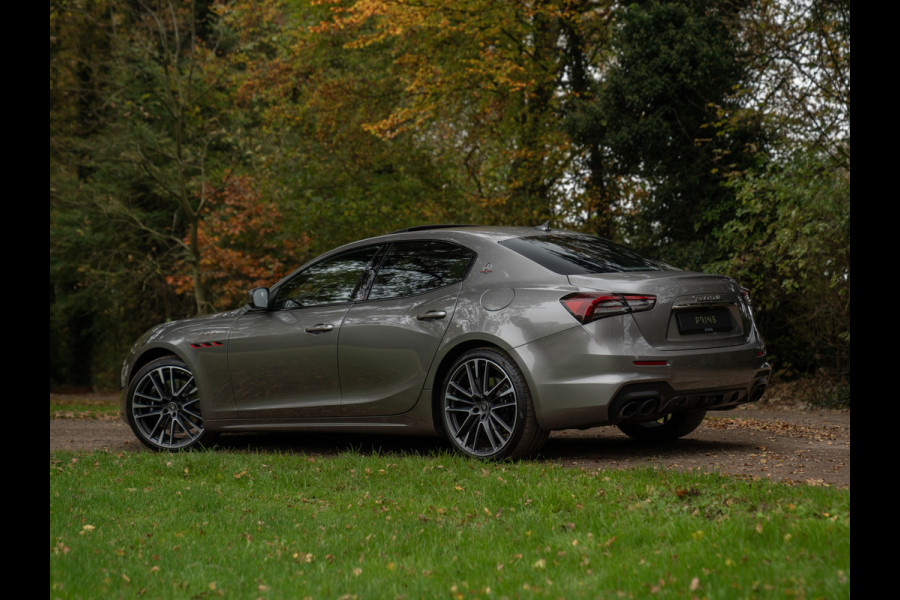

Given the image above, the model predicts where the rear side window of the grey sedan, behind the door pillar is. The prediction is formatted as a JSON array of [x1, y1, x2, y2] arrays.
[[368, 242, 475, 300]]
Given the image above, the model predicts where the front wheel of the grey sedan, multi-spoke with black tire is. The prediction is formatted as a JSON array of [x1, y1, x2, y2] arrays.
[[125, 357, 210, 450]]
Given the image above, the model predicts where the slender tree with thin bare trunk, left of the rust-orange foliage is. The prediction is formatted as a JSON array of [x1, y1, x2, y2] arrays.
[[103, 0, 239, 314]]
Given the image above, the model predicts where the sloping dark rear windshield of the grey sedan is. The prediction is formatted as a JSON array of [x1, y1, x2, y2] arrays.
[[500, 233, 677, 275]]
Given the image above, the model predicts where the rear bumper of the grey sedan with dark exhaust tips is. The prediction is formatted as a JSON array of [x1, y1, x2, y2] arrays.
[[513, 327, 771, 430]]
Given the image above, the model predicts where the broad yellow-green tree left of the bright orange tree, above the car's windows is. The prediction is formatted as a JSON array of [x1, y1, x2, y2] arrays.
[[215, 0, 457, 255]]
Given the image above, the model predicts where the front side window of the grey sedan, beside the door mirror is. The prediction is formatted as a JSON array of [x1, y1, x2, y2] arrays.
[[273, 246, 380, 309]]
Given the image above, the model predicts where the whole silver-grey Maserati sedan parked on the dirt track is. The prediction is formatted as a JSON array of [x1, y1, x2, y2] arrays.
[[122, 225, 770, 459]]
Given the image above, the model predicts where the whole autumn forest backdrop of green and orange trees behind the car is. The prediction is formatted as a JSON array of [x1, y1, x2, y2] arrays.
[[49, 0, 850, 404]]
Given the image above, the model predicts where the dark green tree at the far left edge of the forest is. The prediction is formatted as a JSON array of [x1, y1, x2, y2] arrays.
[[49, 0, 200, 387]]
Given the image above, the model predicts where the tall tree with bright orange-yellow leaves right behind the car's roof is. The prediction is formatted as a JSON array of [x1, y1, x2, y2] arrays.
[[298, 0, 620, 229]]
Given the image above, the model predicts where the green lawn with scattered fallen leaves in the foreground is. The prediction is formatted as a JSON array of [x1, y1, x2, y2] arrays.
[[50, 451, 850, 599]]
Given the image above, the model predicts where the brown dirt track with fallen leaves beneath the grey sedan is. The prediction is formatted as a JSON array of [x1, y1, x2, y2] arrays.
[[50, 394, 850, 488]]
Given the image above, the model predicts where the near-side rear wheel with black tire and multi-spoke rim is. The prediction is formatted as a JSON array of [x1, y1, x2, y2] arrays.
[[440, 348, 550, 460]]
